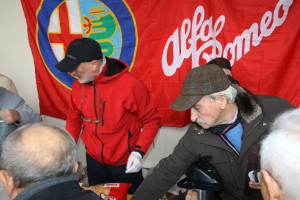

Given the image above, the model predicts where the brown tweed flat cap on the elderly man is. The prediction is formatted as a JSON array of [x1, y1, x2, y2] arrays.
[[171, 64, 230, 111]]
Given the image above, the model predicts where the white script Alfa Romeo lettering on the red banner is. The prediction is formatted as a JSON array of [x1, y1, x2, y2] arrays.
[[161, 0, 293, 76]]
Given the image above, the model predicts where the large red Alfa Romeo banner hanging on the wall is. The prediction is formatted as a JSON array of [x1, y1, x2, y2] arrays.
[[21, 0, 300, 127]]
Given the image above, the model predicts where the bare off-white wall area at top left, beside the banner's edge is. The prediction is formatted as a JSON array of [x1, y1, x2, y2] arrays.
[[0, 0, 39, 110]]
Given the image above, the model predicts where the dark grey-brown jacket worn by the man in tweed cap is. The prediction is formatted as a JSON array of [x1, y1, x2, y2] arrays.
[[132, 91, 293, 200]]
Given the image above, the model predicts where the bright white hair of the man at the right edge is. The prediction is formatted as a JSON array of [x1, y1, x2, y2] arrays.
[[260, 109, 300, 199]]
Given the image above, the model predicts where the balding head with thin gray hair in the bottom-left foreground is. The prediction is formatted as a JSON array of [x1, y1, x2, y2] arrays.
[[0, 123, 76, 187]]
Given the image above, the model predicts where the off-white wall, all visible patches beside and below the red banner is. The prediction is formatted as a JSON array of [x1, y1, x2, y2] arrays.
[[0, 0, 186, 168]]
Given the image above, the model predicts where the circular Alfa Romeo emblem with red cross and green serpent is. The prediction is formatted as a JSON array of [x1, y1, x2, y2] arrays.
[[36, 0, 137, 88]]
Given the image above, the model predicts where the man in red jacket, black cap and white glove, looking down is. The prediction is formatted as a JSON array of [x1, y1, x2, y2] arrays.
[[55, 38, 160, 194]]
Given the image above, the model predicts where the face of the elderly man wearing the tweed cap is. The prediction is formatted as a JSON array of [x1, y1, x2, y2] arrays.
[[191, 97, 222, 129]]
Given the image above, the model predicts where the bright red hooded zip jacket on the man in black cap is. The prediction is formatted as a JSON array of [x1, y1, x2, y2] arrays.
[[66, 58, 160, 165]]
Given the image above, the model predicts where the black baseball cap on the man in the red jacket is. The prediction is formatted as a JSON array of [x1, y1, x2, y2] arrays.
[[55, 38, 103, 72]]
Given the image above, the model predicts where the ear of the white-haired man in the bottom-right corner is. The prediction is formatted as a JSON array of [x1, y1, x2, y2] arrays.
[[260, 169, 281, 200]]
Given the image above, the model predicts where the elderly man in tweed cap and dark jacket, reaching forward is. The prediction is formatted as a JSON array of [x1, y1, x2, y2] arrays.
[[132, 64, 293, 200]]
